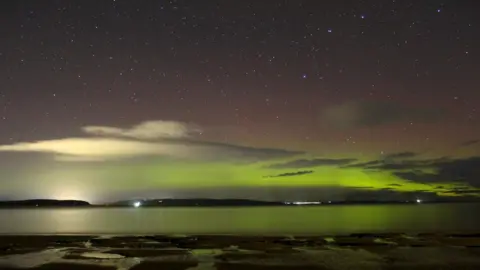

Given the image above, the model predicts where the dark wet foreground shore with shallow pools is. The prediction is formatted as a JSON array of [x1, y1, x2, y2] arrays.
[[0, 234, 480, 270]]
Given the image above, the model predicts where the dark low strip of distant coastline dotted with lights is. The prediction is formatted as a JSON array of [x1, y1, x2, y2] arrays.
[[0, 198, 480, 209]]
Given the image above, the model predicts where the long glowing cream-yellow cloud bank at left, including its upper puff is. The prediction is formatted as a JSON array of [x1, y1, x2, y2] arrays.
[[0, 121, 303, 162]]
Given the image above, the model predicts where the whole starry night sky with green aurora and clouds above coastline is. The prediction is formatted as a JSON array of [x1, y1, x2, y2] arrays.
[[0, 0, 480, 202]]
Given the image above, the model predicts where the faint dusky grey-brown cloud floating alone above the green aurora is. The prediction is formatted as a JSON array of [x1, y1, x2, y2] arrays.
[[321, 101, 444, 129]]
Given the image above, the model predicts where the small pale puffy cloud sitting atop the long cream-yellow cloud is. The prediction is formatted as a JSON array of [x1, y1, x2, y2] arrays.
[[82, 120, 200, 140]]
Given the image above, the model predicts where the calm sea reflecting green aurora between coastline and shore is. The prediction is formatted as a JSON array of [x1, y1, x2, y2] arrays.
[[0, 204, 480, 235]]
